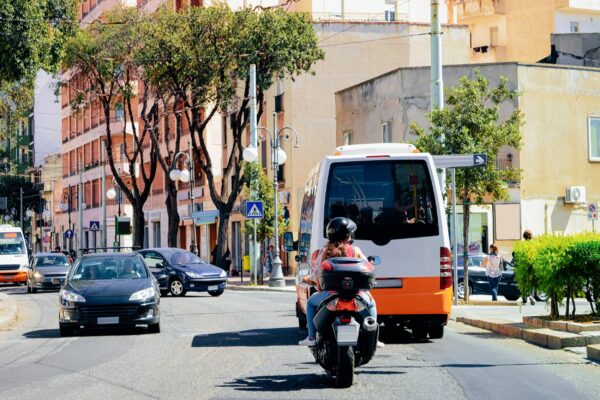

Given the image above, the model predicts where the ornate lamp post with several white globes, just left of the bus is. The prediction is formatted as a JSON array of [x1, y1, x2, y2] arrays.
[[243, 116, 300, 287]]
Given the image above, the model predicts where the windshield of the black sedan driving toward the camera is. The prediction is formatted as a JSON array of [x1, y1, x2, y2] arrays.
[[71, 257, 148, 281]]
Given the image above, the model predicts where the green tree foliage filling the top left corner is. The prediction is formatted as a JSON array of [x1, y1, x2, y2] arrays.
[[0, 0, 78, 83]]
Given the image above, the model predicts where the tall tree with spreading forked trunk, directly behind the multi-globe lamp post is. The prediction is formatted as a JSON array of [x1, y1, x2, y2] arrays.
[[146, 3, 323, 265]]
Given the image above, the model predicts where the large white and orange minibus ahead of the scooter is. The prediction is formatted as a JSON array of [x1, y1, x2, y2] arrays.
[[284, 143, 452, 339]]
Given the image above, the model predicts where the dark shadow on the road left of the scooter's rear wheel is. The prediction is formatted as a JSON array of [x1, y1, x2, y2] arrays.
[[219, 373, 333, 392]]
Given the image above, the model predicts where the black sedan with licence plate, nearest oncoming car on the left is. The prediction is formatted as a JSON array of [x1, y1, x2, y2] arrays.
[[58, 253, 160, 336]]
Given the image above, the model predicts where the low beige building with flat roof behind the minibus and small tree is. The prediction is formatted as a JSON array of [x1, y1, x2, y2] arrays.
[[336, 63, 600, 254]]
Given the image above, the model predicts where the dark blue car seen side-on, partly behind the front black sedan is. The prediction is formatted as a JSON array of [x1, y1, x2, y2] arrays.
[[138, 248, 227, 296]]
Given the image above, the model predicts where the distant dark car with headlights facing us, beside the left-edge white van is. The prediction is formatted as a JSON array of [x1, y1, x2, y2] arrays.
[[27, 253, 71, 293]]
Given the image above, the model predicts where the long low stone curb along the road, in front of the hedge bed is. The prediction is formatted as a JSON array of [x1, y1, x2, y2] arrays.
[[455, 317, 600, 348]]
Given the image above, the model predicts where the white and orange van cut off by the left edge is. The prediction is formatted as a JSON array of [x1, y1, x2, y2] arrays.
[[0, 225, 29, 284]]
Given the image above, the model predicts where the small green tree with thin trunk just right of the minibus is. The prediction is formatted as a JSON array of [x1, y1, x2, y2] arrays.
[[411, 70, 523, 300]]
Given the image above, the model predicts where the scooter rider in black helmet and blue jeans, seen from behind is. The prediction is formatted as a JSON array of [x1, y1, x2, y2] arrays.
[[298, 217, 383, 347]]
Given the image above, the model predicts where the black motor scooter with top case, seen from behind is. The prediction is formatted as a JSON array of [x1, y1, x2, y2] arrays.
[[311, 257, 379, 388]]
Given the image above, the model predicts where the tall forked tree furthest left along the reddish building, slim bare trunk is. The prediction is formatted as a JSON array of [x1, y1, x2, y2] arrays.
[[64, 7, 158, 247]]
